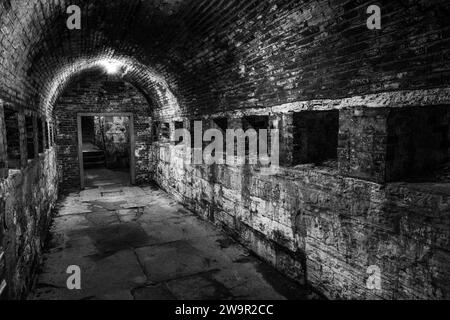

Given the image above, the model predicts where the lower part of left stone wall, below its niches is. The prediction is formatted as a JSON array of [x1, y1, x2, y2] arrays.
[[0, 148, 58, 299]]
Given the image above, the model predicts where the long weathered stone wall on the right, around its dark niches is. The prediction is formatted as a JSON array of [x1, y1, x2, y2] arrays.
[[151, 98, 450, 299]]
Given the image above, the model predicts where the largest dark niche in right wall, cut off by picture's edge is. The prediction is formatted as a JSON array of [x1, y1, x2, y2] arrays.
[[386, 106, 450, 182]]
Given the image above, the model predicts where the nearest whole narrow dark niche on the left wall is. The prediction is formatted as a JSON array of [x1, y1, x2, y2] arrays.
[[4, 107, 20, 169]]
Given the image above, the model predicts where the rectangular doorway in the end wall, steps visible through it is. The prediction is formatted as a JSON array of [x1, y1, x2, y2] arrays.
[[78, 113, 135, 189]]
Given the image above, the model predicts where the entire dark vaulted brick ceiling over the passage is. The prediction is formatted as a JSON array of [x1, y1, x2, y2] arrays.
[[0, 0, 450, 119]]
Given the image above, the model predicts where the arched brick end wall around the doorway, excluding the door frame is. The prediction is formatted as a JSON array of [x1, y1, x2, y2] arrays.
[[54, 73, 151, 190]]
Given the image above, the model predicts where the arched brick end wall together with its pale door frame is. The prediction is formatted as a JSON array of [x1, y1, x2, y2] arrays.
[[52, 69, 152, 191]]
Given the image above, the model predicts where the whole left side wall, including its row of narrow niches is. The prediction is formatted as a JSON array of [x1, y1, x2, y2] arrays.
[[0, 95, 58, 299]]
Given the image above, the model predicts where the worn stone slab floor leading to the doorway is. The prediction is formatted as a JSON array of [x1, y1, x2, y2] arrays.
[[29, 185, 315, 300]]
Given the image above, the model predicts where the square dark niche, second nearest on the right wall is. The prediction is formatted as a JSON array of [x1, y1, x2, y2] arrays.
[[292, 110, 339, 167]]
